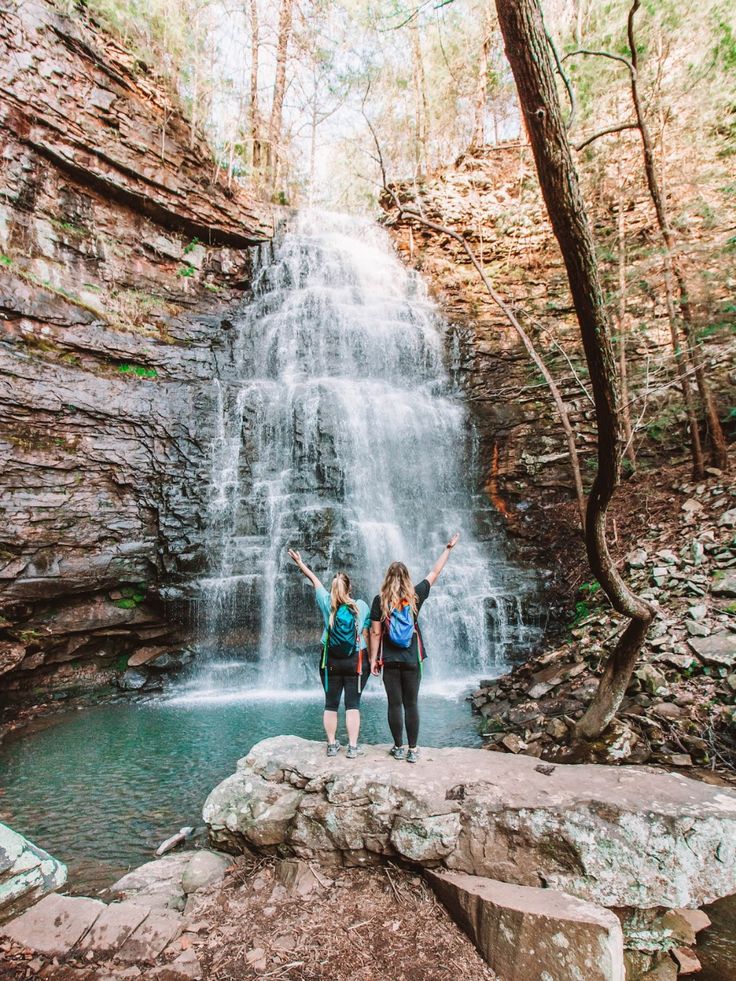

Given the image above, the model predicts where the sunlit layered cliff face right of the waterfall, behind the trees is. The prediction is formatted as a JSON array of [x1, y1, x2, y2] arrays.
[[382, 140, 736, 538]]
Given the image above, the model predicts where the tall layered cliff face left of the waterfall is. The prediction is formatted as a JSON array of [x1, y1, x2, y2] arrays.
[[0, 0, 272, 691]]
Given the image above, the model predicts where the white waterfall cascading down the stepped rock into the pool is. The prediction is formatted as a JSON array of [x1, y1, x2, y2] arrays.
[[193, 212, 537, 687]]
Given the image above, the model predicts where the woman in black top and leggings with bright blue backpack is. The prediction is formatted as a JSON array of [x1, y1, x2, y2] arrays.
[[370, 534, 460, 763]]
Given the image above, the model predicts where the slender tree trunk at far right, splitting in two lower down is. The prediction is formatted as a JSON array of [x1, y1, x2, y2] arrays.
[[627, 0, 728, 477]]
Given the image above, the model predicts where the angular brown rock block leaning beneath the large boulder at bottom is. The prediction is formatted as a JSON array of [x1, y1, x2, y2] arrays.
[[428, 872, 625, 981]]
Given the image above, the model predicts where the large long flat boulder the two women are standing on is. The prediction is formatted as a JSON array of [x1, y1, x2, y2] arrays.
[[204, 736, 736, 908]]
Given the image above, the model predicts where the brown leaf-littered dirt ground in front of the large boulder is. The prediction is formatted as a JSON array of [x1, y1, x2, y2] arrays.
[[0, 856, 496, 981]]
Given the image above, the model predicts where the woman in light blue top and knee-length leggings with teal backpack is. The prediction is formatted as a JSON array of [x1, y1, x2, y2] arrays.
[[289, 548, 369, 760]]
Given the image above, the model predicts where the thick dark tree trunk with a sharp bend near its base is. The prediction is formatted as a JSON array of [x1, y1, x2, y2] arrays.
[[496, 0, 654, 738]]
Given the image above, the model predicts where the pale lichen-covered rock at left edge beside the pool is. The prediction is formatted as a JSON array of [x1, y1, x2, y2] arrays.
[[0, 824, 66, 923]]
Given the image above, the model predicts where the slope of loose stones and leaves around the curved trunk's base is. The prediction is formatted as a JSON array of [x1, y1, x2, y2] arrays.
[[473, 456, 736, 781]]
